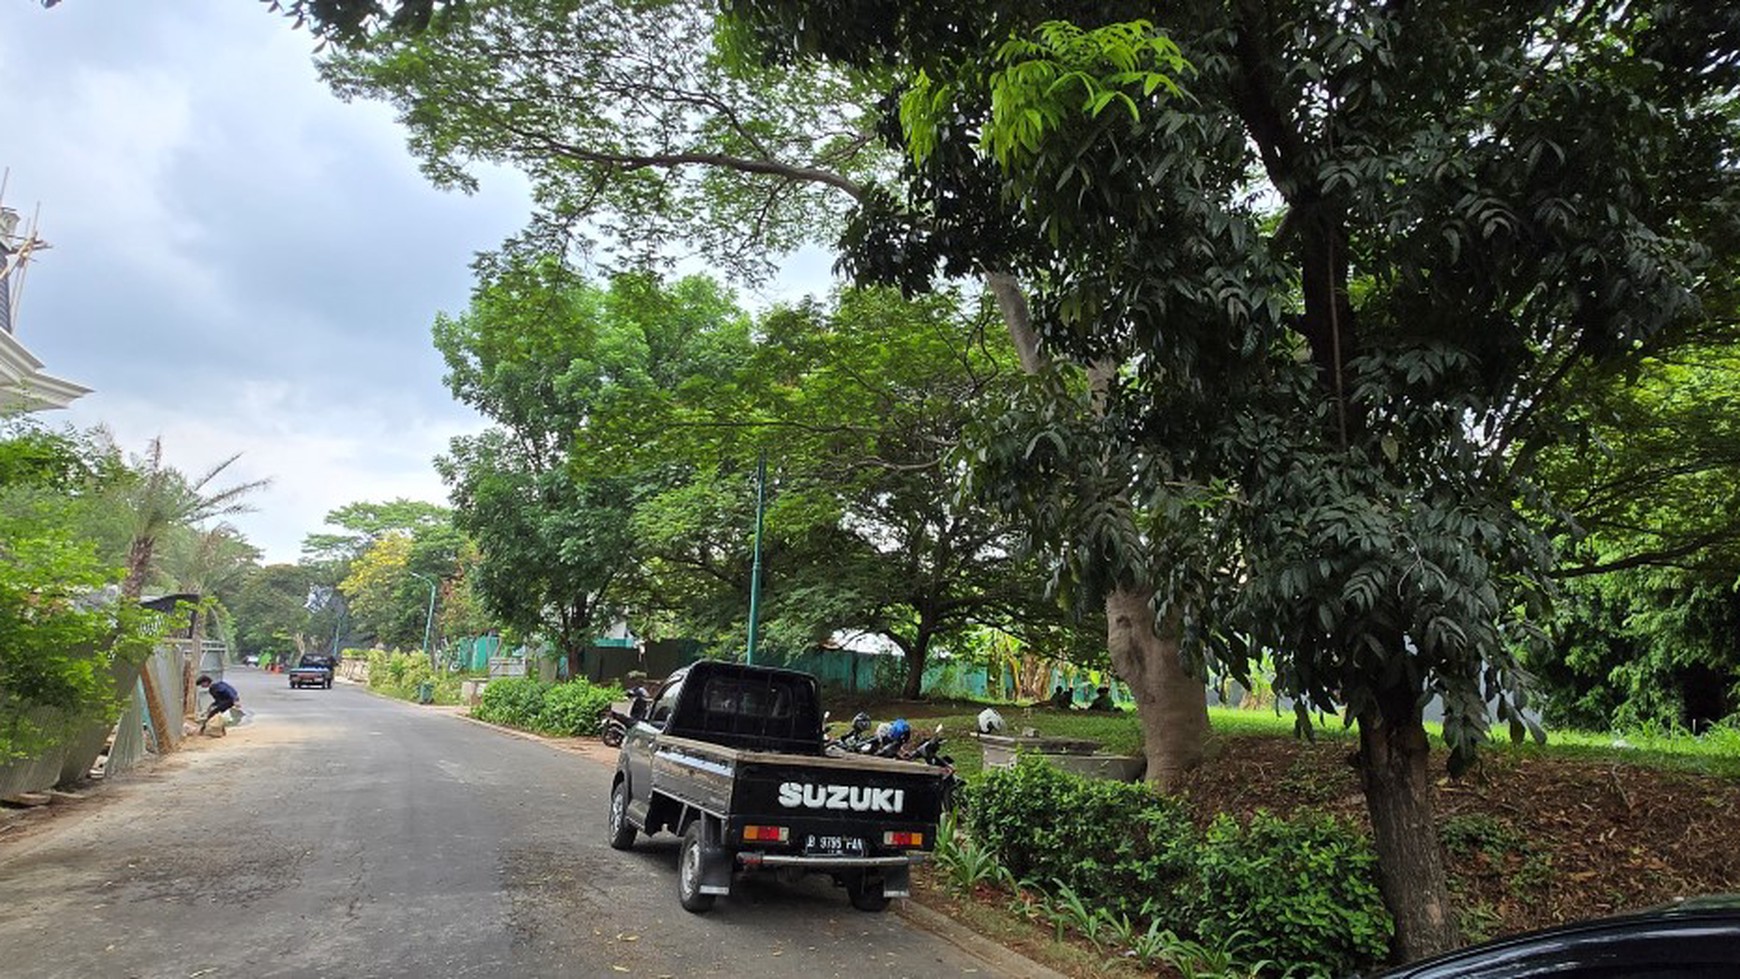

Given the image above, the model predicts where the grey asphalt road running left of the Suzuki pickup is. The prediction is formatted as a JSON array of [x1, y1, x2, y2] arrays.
[[0, 671, 1011, 979]]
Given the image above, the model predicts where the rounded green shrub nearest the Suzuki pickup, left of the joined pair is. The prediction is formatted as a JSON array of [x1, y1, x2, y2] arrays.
[[967, 756, 1195, 916]]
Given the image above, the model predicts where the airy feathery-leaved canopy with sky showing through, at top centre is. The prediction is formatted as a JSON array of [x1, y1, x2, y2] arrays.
[[322, 0, 889, 276]]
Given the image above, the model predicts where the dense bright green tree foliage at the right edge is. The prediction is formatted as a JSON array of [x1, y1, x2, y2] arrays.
[[1531, 344, 1740, 730]]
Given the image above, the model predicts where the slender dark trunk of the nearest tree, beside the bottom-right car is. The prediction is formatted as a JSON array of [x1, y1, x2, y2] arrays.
[[1357, 690, 1460, 963]]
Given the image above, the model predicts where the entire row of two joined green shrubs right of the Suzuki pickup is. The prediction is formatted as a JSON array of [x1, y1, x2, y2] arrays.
[[966, 756, 1392, 974]]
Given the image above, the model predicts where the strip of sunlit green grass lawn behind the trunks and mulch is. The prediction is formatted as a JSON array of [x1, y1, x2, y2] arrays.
[[872, 703, 1740, 779]]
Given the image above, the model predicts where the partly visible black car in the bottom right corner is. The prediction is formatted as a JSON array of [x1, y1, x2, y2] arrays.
[[1373, 894, 1740, 979]]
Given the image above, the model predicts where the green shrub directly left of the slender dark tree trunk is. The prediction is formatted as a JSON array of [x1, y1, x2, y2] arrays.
[[1185, 812, 1394, 976]]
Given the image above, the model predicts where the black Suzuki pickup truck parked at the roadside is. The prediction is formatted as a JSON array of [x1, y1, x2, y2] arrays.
[[609, 661, 945, 911]]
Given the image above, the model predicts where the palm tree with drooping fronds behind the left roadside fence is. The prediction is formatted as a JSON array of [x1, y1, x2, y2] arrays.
[[120, 436, 271, 751]]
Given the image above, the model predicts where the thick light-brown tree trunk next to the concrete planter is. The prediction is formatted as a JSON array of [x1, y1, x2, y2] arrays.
[[1105, 588, 1208, 789]]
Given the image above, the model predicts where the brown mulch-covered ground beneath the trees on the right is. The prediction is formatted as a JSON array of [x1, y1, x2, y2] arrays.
[[1183, 737, 1740, 939]]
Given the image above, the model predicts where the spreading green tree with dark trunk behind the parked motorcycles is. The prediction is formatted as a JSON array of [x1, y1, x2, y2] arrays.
[[748, 290, 1061, 697]]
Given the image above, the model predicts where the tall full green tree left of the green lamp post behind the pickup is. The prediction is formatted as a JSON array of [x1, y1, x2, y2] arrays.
[[435, 261, 748, 675]]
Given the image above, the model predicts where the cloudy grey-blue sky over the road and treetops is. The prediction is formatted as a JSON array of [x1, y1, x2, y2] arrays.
[[0, 0, 827, 562]]
